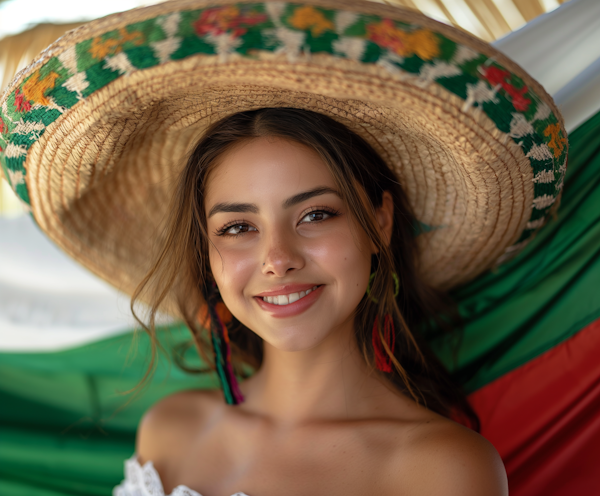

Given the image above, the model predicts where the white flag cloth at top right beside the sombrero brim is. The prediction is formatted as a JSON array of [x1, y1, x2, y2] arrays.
[[492, 0, 600, 132]]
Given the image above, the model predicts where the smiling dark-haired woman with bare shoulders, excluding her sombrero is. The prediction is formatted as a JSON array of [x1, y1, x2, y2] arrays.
[[124, 109, 507, 496]]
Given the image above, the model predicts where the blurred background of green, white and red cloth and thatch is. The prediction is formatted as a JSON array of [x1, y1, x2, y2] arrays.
[[0, 0, 600, 496]]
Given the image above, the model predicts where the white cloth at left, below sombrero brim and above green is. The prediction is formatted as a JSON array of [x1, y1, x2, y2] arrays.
[[0, 215, 133, 351]]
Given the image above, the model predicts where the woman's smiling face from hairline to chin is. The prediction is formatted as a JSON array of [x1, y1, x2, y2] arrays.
[[204, 138, 372, 351]]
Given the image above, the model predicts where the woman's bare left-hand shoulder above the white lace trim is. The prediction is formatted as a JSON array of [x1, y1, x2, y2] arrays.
[[136, 390, 223, 468]]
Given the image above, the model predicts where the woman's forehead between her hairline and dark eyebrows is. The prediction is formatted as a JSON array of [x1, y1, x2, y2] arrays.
[[205, 137, 335, 207]]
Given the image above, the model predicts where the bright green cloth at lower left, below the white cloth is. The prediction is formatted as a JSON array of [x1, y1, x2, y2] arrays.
[[0, 327, 218, 496]]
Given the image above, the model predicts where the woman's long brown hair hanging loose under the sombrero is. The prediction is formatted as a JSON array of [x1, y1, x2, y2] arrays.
[[132, 108, 479, 429]]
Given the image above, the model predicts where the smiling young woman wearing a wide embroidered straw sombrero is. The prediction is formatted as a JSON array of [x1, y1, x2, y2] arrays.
[[0, 0, 567, 496]]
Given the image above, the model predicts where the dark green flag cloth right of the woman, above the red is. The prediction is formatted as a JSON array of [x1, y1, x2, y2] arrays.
[[431, 108, 600, 391]]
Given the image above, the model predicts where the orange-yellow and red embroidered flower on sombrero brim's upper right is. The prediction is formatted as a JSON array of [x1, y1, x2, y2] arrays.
[[367, 19, 440, 60]]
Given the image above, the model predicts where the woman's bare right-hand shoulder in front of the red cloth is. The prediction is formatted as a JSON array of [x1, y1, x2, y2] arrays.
[[390, 415, 508, 496]]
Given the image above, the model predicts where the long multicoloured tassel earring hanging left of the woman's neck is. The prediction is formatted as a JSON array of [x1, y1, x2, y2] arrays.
[[207, 285, 244, 405]]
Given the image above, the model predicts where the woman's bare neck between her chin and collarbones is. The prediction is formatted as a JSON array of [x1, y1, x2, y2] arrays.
[[242, 325, 396, 425]]
